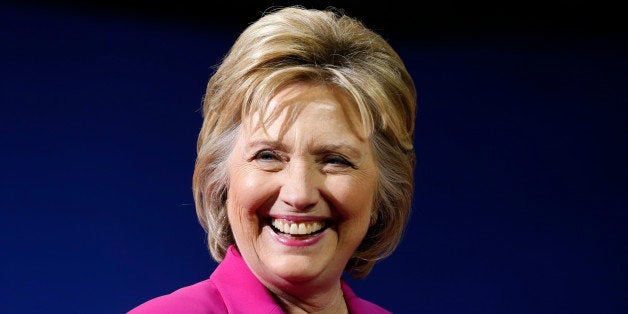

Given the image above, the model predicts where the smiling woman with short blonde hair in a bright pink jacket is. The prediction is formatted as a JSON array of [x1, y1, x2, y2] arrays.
[[131, 7, 416, 314]]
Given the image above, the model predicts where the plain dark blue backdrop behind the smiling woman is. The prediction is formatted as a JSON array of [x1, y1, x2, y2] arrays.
[[0, 2, 628, 314]]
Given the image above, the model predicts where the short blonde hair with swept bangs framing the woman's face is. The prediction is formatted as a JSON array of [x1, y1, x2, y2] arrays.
[[193, 6, 416, 278]]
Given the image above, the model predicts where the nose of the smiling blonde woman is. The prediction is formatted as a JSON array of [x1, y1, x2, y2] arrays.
[[279, 162, 322, 210]]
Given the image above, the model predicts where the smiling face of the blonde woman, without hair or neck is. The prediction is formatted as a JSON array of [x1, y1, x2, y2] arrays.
[[227, 84, 377, 289]]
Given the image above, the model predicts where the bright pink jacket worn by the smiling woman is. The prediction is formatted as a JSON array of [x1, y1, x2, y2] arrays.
[[128, 246, 391, 314]]
